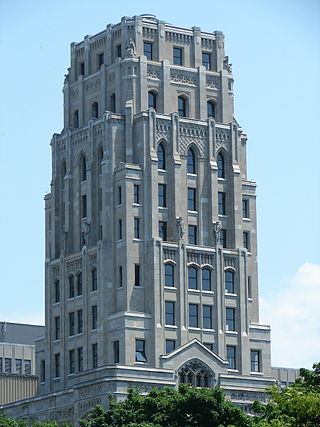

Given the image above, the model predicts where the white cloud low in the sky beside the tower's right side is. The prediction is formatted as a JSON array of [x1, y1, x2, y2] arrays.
[[260, 263, 320, 368]]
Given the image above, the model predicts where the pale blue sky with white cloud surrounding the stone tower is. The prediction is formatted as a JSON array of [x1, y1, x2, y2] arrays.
[[0, 0, 320, 367]]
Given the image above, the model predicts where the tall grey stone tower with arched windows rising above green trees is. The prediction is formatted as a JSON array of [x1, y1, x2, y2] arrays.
[[37, 15, 273, 417]]
